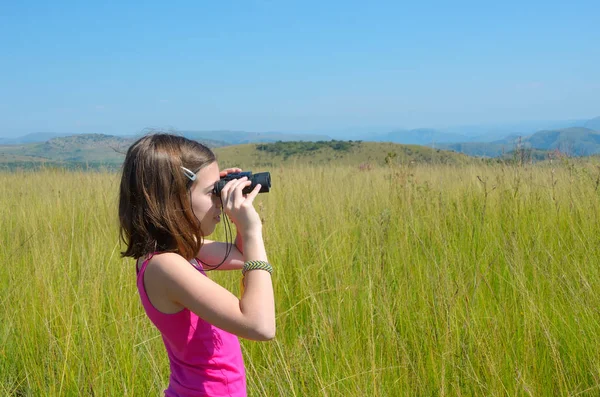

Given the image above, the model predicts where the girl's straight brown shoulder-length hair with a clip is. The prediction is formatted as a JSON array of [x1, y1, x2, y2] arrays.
[[119, 133, 216, 260]]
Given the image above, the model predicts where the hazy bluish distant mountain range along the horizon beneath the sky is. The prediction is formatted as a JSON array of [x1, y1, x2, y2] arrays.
[[0, 117, 600, 165]]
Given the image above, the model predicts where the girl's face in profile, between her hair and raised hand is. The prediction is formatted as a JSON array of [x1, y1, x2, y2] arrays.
[[191, 162, 221, 236]]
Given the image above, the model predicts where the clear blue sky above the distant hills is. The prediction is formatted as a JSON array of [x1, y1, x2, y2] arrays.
[[0, 0, 600, 136]]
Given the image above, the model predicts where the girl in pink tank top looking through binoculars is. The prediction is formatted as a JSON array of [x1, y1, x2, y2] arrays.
[[119, 134, 275, 396]]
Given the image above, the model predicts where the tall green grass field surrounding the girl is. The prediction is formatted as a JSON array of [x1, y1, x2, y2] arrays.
[[0, 162, 600, 396]]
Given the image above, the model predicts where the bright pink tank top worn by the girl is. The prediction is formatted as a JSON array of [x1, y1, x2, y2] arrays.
[[137, 254, 246, 397]]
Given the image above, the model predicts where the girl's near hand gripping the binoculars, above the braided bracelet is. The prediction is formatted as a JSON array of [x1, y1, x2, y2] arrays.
[[221, 177, 262, 237]]
